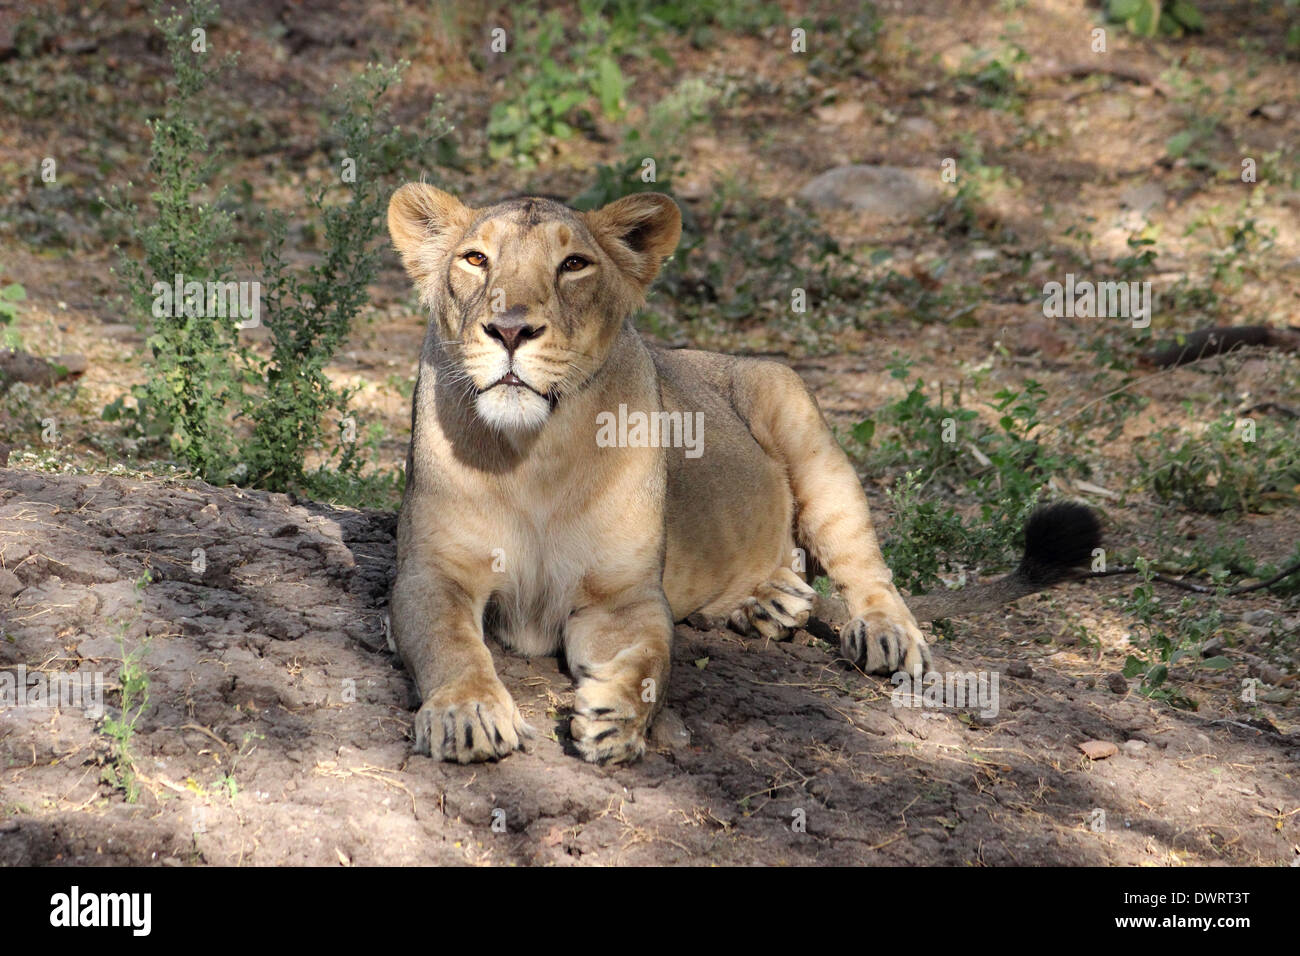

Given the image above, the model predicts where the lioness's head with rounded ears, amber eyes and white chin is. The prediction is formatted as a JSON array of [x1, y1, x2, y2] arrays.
[[389, 183, 681, 432]]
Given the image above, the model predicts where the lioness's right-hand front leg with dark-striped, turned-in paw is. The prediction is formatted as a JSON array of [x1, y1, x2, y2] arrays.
[[564, 587, 672, 762]]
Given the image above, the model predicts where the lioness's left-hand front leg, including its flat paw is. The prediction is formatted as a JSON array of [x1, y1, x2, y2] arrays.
[[390, 535, 532, 763]]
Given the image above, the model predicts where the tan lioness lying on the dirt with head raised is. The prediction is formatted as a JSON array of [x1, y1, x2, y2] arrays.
[[389, 183, 1097, 763]]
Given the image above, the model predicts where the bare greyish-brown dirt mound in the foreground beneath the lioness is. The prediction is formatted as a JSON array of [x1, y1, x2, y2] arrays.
[[0, 470, 1300, 865]]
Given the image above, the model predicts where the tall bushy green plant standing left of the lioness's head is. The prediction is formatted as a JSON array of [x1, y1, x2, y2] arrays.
[[104, 0, 446, 502]]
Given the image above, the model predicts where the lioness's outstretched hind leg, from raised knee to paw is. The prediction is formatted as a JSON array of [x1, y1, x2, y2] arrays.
[[735, 360, 930, 675]]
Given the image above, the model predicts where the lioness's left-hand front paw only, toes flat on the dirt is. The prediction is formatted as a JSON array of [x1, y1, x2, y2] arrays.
[[415, 675, 533, 763]]
